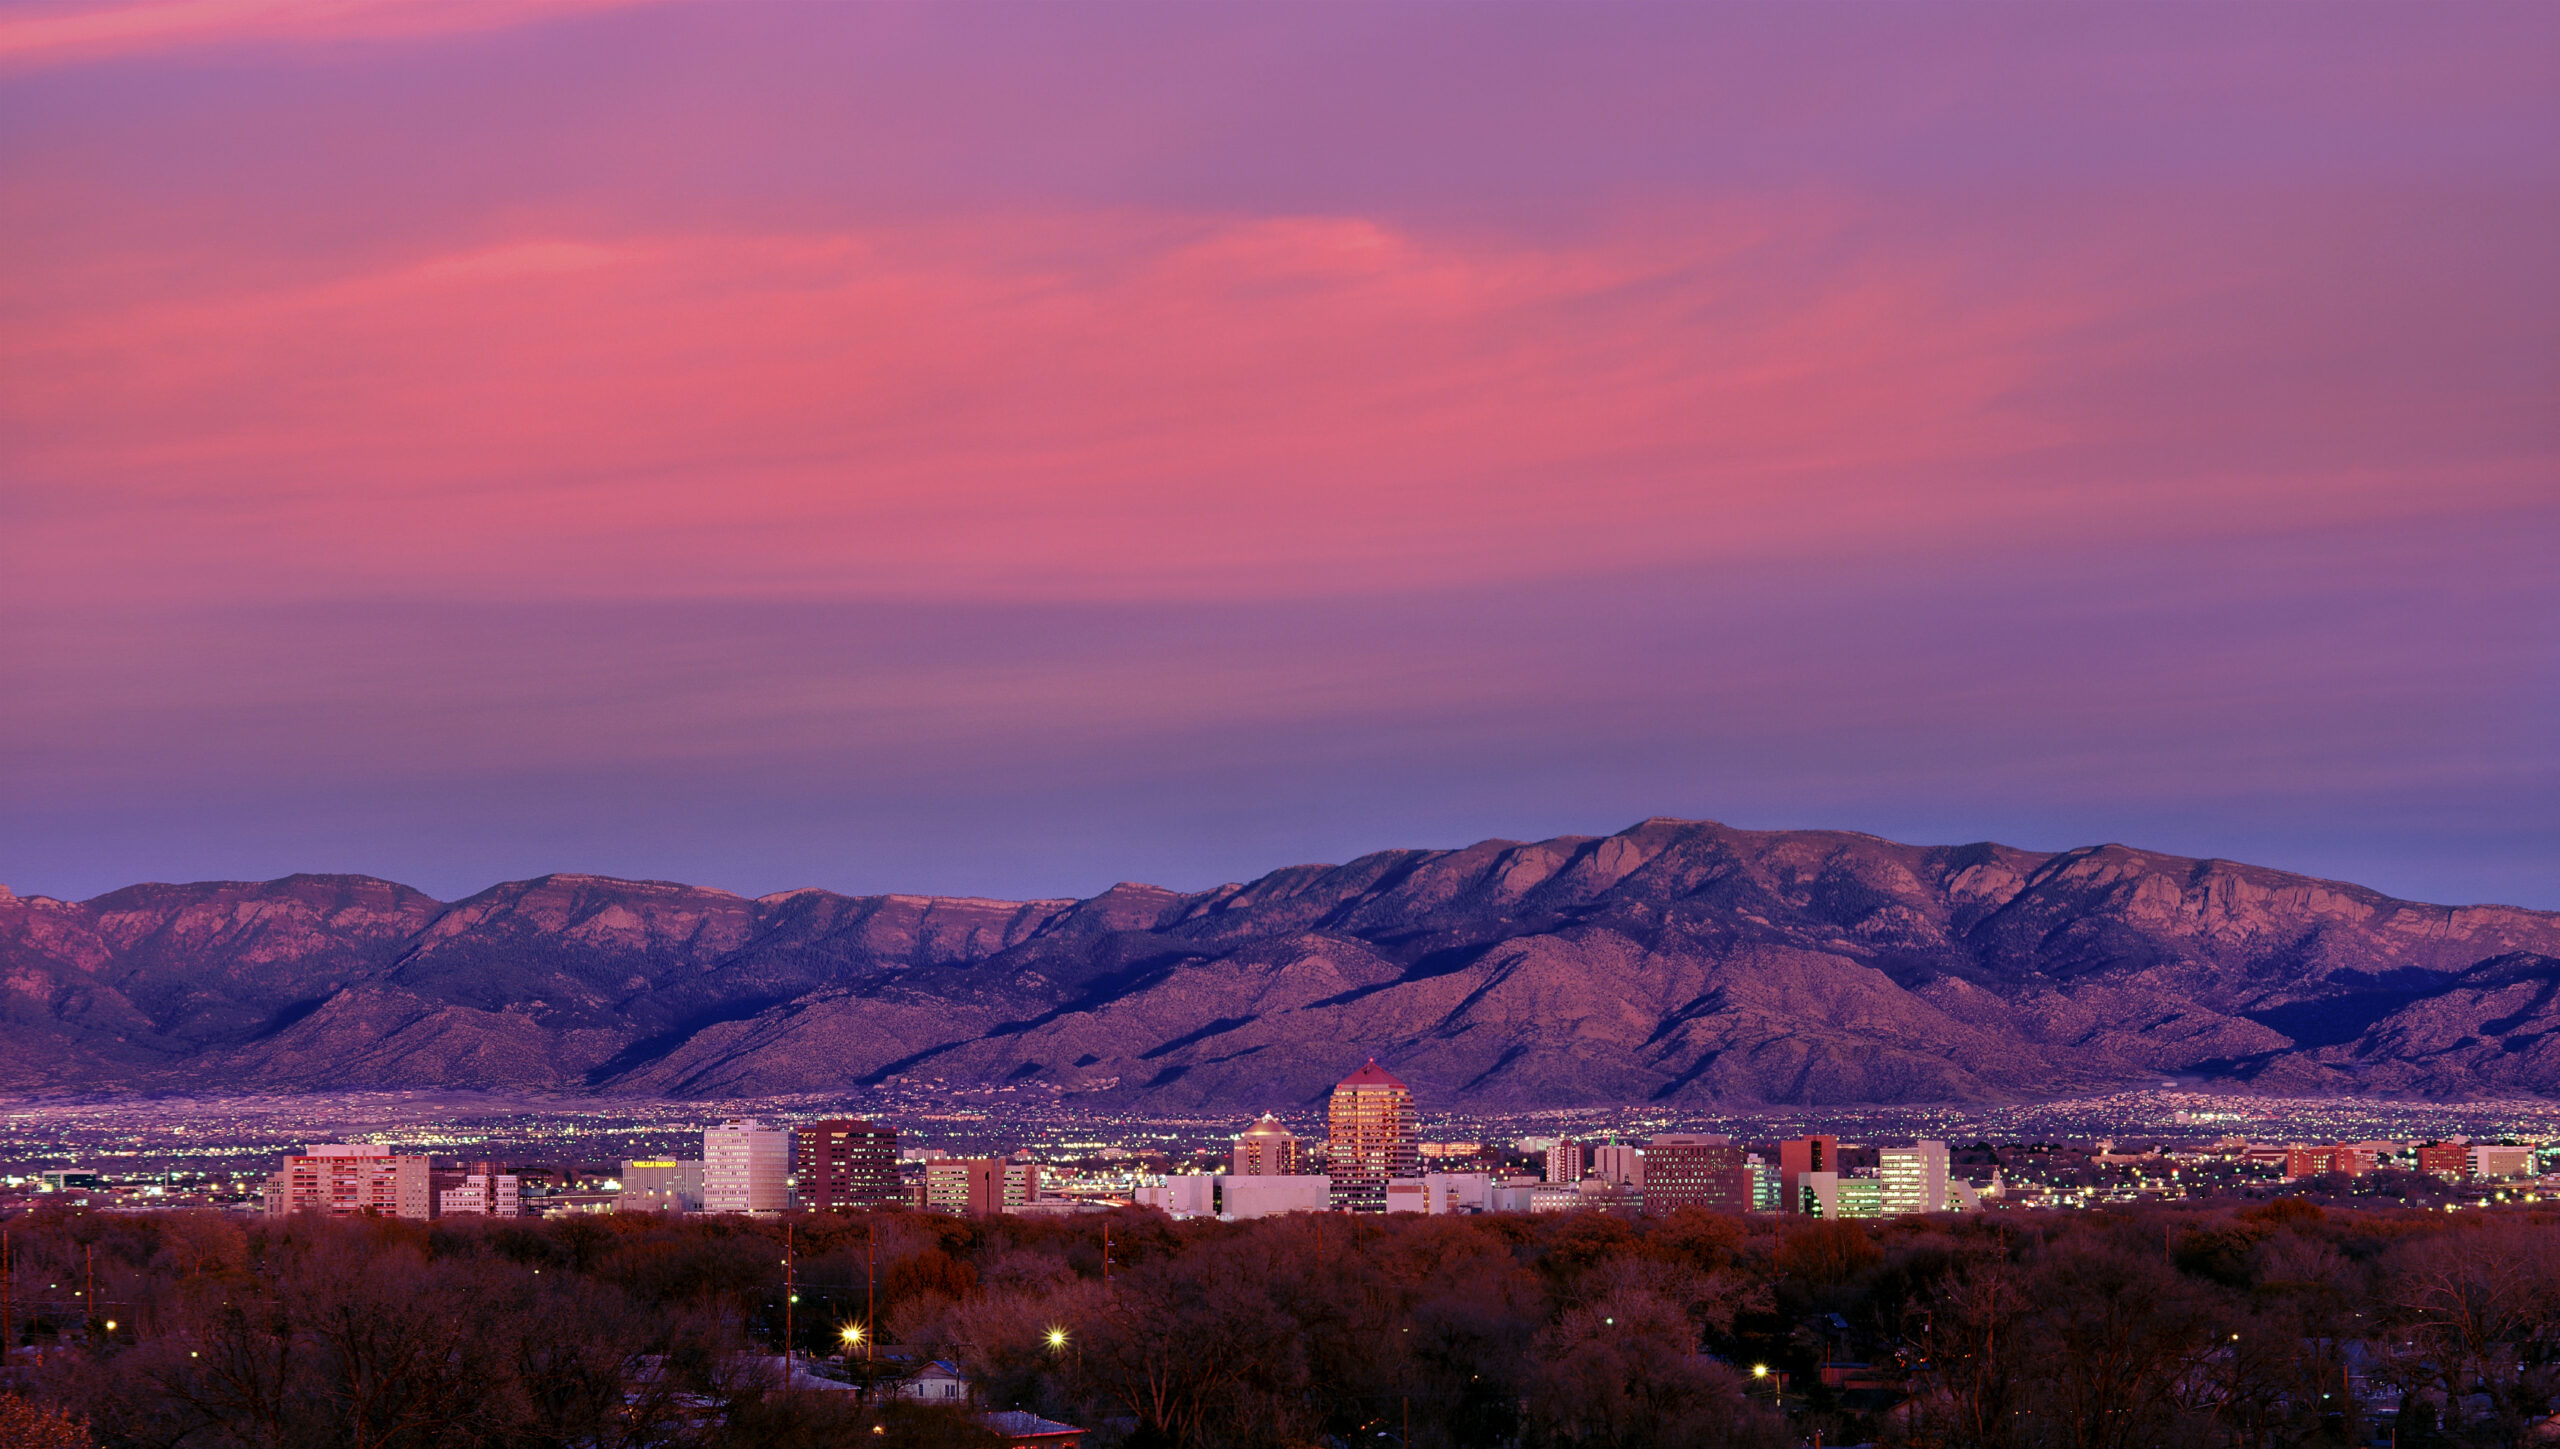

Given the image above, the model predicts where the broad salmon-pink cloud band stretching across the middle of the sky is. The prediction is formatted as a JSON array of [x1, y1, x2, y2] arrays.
[[20, 193, 2527, 614]]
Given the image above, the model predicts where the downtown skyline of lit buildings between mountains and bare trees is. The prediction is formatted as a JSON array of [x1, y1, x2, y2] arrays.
[[244, 1060, 2537, 1219]]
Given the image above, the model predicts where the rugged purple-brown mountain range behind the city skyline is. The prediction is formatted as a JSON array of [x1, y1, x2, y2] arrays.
[[0, 819, 2560, 1109]]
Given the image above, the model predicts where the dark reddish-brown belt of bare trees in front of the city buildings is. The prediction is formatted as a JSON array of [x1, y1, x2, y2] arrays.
[[0, 1201, 2560, 1449]]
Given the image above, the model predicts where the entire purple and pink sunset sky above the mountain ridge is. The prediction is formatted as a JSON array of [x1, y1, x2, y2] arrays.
[[0, 0, 2560, 909]]
